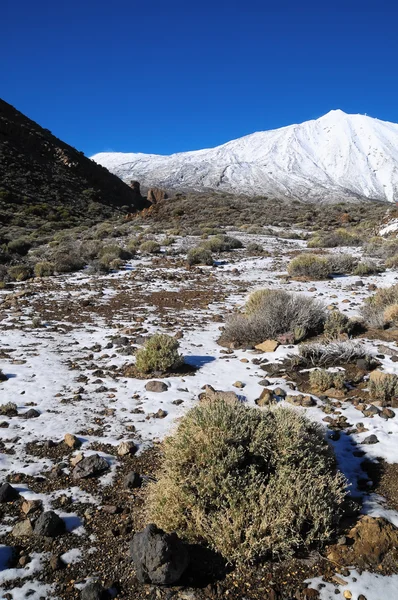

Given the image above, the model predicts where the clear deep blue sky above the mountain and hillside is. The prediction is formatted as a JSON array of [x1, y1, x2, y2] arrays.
[[0, 0, 398, 155]]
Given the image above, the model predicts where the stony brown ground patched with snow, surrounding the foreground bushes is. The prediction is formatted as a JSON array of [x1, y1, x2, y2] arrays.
[[0, 227, 398, 600]]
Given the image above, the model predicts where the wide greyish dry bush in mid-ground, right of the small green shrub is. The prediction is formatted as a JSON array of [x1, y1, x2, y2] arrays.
[[220, 290, 326, 346]]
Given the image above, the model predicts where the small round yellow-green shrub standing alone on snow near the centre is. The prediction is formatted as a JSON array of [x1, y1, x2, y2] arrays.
[[135, 333, 184, 373]]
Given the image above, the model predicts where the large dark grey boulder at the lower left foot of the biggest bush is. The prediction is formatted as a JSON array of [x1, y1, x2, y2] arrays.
[[130, 524, 189, 585]]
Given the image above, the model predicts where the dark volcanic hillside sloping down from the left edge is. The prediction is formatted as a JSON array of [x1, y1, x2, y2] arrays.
[[0, 100, 140, 234]]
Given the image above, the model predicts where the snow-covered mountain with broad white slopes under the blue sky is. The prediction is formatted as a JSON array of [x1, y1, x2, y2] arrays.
[[92, 110, 398, 202]]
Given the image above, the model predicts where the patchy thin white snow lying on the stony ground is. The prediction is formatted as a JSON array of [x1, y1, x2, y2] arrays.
[[0, 233, 398, 600]]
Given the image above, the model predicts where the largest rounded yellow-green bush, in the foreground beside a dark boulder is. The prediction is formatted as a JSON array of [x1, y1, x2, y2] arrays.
[[148, 399, 346, 562]]
